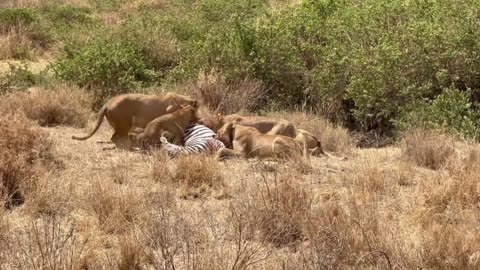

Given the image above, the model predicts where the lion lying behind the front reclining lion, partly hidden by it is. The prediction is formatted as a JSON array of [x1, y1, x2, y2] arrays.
[[199, 114, 343, 159]]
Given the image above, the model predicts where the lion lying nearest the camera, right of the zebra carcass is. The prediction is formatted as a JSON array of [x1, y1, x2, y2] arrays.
[[216, 123, 308, 160]]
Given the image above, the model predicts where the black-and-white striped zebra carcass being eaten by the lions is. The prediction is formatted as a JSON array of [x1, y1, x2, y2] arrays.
[[160, 123, 225, 157]]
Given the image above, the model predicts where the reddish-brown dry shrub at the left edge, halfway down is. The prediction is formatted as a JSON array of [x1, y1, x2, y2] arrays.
[[0, 114, 55, 207]]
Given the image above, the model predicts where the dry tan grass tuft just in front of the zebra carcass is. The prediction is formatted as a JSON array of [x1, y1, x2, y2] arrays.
[[175, 155, 226, 198]]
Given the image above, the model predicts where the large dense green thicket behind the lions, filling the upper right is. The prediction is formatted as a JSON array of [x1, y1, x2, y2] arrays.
[[152, 0, 480, 138]]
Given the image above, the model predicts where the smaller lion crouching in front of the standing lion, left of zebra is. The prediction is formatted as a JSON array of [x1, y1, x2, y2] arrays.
[[128, 105, 198, 148]]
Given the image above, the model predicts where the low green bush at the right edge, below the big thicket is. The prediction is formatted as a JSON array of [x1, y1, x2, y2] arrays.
[[397, 88, 480, 139]]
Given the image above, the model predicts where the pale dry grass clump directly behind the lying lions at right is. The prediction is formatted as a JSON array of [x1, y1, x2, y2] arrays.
[[268, 112, 353, 153]]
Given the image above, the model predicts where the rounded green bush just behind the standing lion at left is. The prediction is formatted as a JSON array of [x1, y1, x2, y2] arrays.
[[51, 39, 151, 108]]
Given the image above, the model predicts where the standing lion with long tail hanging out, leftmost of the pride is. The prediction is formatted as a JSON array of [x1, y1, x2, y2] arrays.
[[72, 92, 198, 149]]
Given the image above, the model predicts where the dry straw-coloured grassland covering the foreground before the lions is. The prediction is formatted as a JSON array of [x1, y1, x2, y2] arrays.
[[0, 97, 480, 270]]
